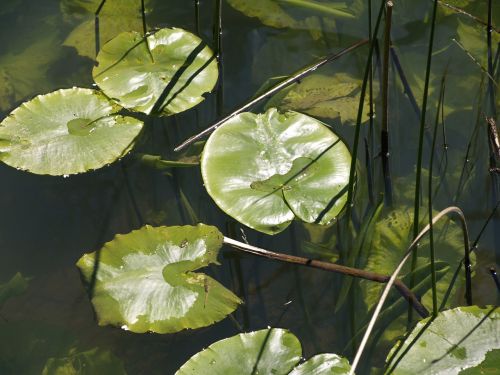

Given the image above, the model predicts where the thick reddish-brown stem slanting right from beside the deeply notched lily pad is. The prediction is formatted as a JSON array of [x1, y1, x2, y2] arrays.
[[224, 237, 429, 317]]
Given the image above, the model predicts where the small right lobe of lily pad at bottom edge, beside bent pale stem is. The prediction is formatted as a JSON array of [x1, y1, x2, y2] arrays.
[[290, 353, 351, 375]]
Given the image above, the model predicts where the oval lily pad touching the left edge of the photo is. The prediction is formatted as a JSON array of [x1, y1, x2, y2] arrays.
[[0, 88, 143, 176]]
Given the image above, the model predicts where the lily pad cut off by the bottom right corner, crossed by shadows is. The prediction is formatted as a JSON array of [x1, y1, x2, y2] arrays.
[[388, 306, 500, 374]]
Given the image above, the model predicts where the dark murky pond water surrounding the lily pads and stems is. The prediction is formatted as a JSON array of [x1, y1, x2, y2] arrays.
[[0, 0, 500, 374]]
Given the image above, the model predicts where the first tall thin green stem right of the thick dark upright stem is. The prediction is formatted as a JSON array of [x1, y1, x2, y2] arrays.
[[408, 0, 438, 323]]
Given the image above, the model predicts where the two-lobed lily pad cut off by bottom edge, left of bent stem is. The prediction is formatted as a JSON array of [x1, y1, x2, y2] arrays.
[[176, 328, 350, 375]]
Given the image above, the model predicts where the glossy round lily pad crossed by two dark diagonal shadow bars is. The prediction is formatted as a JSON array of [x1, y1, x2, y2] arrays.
[[92, 28, 218, 115]]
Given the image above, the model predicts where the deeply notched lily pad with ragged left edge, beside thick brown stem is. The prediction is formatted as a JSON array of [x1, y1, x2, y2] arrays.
[[77, 224, 241, 333]]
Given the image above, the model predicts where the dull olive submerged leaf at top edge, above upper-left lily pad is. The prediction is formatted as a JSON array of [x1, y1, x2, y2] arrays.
[[61, 0, 149, 59]]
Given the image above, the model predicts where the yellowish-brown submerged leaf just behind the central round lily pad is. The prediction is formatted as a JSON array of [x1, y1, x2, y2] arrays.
[[266, 73, 370, 124]]
